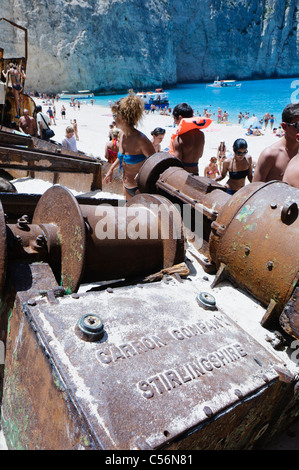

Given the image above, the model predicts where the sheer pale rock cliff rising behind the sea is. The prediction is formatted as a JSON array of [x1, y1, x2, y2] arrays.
[[0, 0, 299, 93]]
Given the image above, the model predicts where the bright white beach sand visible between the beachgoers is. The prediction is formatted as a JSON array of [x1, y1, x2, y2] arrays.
[[11, 98, 279, 193]]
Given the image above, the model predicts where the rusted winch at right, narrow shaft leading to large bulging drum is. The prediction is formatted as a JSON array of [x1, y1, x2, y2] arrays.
[[138, 153, 299, 338]]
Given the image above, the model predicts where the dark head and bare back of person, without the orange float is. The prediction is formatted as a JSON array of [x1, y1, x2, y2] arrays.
[[172, 103, 205, 175]]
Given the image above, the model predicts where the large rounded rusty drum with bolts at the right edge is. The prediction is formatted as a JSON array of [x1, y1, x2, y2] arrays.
[[210, 181, 299, 318]]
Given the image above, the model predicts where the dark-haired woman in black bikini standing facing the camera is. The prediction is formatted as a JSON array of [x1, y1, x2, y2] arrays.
[[215, 139, 252, 195]]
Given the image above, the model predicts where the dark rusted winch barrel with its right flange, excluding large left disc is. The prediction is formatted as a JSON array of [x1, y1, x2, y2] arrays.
[[81, 194, 185, 282]]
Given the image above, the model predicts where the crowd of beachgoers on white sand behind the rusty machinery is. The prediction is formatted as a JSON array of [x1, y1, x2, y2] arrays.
[[20, 91, 299, 199]]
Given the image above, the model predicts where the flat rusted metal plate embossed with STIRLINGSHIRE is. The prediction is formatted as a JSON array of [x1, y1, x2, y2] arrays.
[[13, 284, 283, 449]]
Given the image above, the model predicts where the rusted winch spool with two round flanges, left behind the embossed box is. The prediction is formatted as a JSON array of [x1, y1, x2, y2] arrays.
[[0, 186, 185, 292]]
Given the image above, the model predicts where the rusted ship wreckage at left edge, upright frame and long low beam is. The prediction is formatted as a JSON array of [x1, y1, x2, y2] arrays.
[[0, 18, 102, 191]]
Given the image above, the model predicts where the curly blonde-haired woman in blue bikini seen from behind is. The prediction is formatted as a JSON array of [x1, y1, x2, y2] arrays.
[[104, 91, 155, 199]]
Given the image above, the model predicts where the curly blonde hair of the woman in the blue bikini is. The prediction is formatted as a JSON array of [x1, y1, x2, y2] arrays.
[[111, 90, 144, 127]]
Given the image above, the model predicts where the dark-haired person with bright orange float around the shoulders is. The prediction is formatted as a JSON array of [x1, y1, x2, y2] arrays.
[[169, 103, 212, 175]]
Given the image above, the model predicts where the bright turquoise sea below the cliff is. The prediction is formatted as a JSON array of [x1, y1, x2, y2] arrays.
[[95, 78, 299, 124]]
